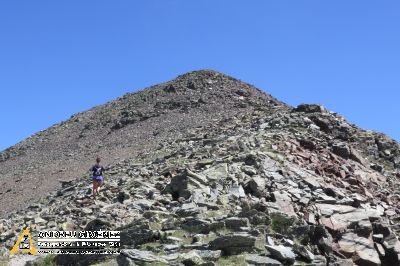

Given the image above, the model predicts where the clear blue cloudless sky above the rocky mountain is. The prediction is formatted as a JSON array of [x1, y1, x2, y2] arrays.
[[0, 0, 400, 150]]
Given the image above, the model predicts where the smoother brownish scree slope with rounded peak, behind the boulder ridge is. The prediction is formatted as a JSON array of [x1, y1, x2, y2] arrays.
[[0, 71, 282, 217]]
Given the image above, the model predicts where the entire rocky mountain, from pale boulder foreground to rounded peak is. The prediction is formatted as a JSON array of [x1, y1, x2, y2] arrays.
[[0, 71, 400, 266]]
